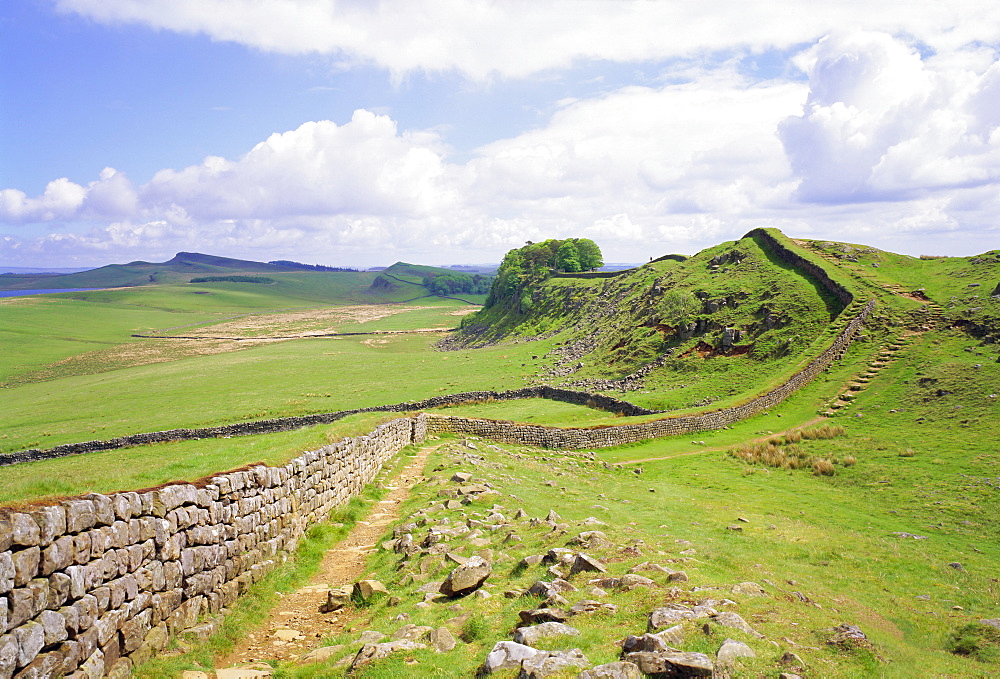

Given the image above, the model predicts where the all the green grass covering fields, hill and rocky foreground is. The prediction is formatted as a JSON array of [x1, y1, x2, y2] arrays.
[[0, 238, 1000, 677]]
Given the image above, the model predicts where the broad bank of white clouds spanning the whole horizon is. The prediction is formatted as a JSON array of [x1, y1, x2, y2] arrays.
[[0, 33, 1000, 265]]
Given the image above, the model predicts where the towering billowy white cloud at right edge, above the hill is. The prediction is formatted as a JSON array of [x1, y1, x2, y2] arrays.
[[780, 33, 1000, 203]]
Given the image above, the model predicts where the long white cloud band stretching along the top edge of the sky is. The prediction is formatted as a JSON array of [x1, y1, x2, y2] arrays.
[[57, 0, 1000, 80]]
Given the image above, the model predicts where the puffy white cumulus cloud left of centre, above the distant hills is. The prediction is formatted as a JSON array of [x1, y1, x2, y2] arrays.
[[142, 110, 448, 219]]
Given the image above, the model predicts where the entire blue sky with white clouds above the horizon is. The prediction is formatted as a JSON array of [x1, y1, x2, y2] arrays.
[[0, 0, 1000, 267]]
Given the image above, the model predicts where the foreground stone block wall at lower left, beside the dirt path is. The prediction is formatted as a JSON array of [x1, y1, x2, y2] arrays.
[[0, 418, 425, 679]]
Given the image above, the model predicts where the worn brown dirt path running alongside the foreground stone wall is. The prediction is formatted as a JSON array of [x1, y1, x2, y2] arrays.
[[216, 447, 435, 668]]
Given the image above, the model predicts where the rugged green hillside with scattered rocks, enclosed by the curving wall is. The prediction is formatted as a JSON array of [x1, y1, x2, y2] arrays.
[[463, 238, 841, 410]]
